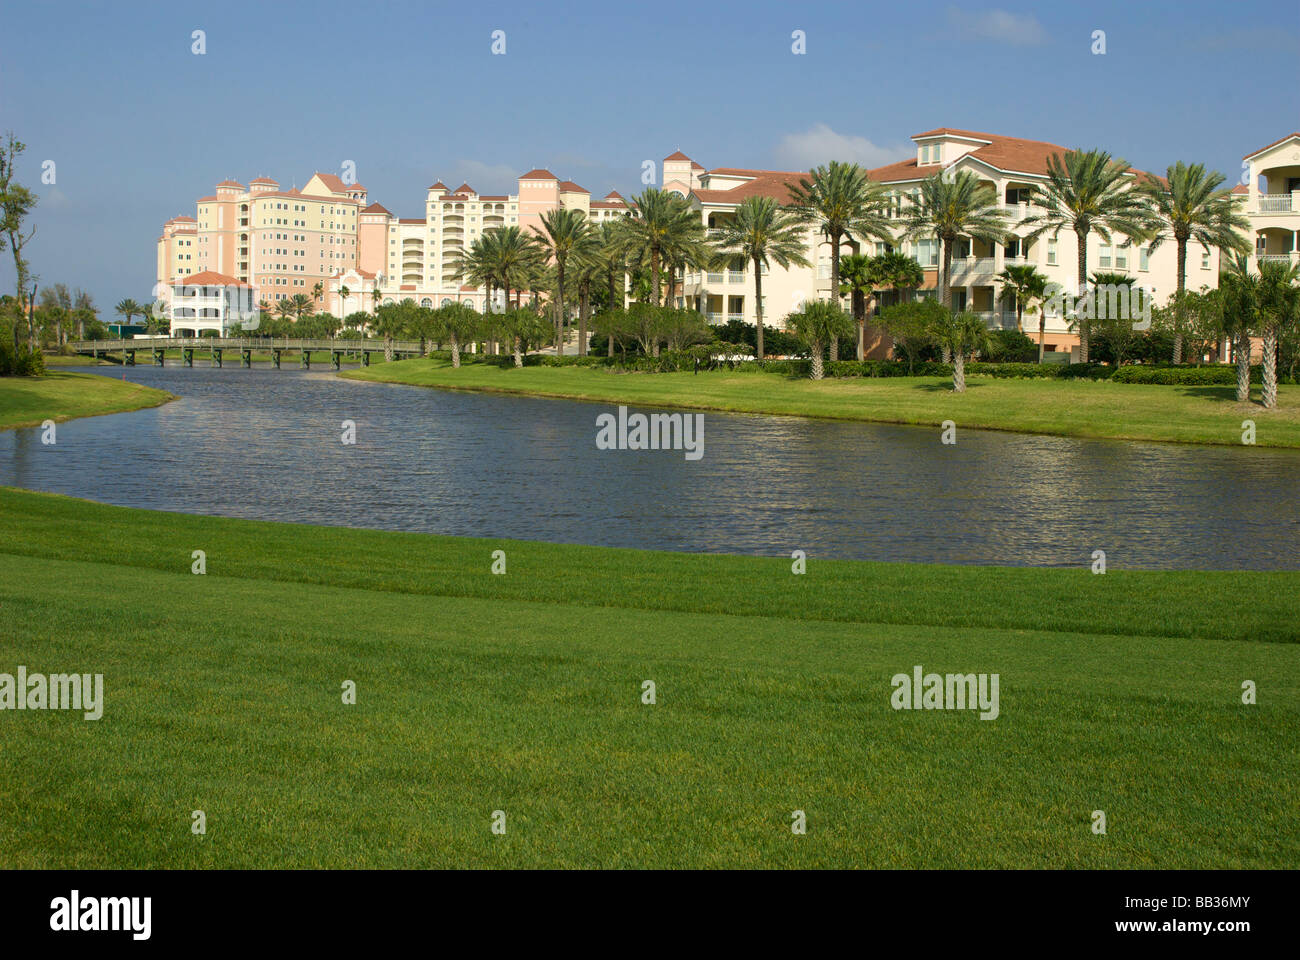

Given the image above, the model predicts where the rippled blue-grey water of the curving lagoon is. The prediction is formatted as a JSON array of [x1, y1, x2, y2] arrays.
[[0, 367, 1300, 564]]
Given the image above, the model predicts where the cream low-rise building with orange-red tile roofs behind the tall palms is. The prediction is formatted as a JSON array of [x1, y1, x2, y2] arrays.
[[664, 127, 1227, 356]]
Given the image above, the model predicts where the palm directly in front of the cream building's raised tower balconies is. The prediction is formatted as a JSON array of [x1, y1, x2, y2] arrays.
[[902, 170, 1006, 320]]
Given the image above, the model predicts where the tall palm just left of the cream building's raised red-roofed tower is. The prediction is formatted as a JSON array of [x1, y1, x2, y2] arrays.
[[790, 160, 893, 360]]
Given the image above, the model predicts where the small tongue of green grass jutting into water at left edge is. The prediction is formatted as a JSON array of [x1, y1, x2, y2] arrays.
[[0, 371, 176, 429]]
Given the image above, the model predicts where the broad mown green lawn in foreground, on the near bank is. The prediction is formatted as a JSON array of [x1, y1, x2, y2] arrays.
[[0, 489, 1300, 868]]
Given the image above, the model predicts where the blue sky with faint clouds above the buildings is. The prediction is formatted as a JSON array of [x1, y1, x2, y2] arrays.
[[0, 0, 1300, 312]]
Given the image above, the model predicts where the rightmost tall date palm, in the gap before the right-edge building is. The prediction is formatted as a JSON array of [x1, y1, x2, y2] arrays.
[[1141, 160, 1251, 363]]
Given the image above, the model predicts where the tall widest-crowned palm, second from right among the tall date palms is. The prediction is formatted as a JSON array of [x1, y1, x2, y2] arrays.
[[1022, 150, 1158, 363]]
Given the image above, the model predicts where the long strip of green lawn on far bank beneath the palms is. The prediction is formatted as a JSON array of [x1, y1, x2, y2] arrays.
[[341, 359, 1300, 447]]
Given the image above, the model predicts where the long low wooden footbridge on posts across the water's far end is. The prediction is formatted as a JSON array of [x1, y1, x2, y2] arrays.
[[68, 337, 432, 369]]
